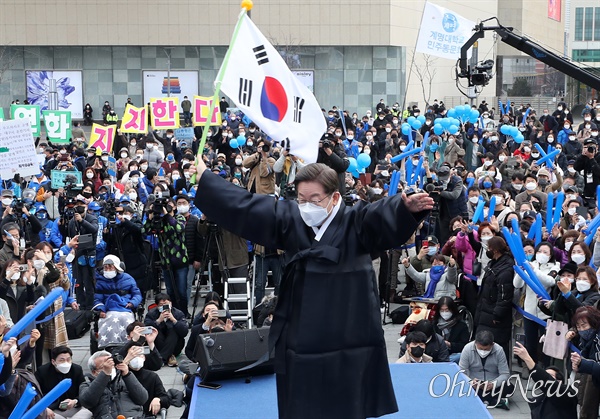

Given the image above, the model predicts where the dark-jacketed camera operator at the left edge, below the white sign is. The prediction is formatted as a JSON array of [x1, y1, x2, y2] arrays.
[[0, 190, 42, 247]]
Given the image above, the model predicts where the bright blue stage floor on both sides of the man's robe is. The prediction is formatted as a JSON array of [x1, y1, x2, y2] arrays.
[[189, 363, 492, 419]]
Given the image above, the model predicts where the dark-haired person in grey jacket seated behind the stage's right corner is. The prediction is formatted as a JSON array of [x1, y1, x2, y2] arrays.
[[458, 330, 514, 410]]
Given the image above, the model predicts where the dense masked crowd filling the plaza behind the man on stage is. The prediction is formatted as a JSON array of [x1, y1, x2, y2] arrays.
[[0, 98, 600, 418]]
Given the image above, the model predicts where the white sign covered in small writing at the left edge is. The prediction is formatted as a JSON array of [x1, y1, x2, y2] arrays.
[[0, 118, 40, 179]]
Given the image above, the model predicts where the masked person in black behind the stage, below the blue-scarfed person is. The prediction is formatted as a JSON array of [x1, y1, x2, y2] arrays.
[[433, 297, 469, 364]]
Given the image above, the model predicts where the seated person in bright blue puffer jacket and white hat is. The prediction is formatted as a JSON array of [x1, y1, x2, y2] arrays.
[[94, 255, 142, 318]]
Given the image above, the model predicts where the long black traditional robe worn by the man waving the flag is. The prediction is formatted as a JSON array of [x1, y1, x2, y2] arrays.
[[196, 172, 426, 418]]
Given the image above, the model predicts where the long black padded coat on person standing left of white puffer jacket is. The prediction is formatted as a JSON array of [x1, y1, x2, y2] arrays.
[[475, 254, 515, 345]]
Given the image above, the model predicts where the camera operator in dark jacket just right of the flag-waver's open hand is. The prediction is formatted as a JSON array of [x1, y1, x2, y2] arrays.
[[425, 163, 469, 243]]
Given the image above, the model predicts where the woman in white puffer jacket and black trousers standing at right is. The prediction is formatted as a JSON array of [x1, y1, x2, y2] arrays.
[[513, 242, 560, 363]]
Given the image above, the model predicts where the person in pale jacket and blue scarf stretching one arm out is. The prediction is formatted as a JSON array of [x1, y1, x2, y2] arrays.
[[402, 254, 457, 300]]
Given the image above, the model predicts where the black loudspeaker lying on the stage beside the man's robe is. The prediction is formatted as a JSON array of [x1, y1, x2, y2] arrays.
[[194, 327, 274, 381]]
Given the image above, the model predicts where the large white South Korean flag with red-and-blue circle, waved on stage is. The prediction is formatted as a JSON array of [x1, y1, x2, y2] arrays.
[[217, 13, 327, 163]]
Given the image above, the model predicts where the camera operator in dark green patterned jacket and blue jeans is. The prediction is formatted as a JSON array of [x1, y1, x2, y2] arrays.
[[142, 199, 189, 315]]
